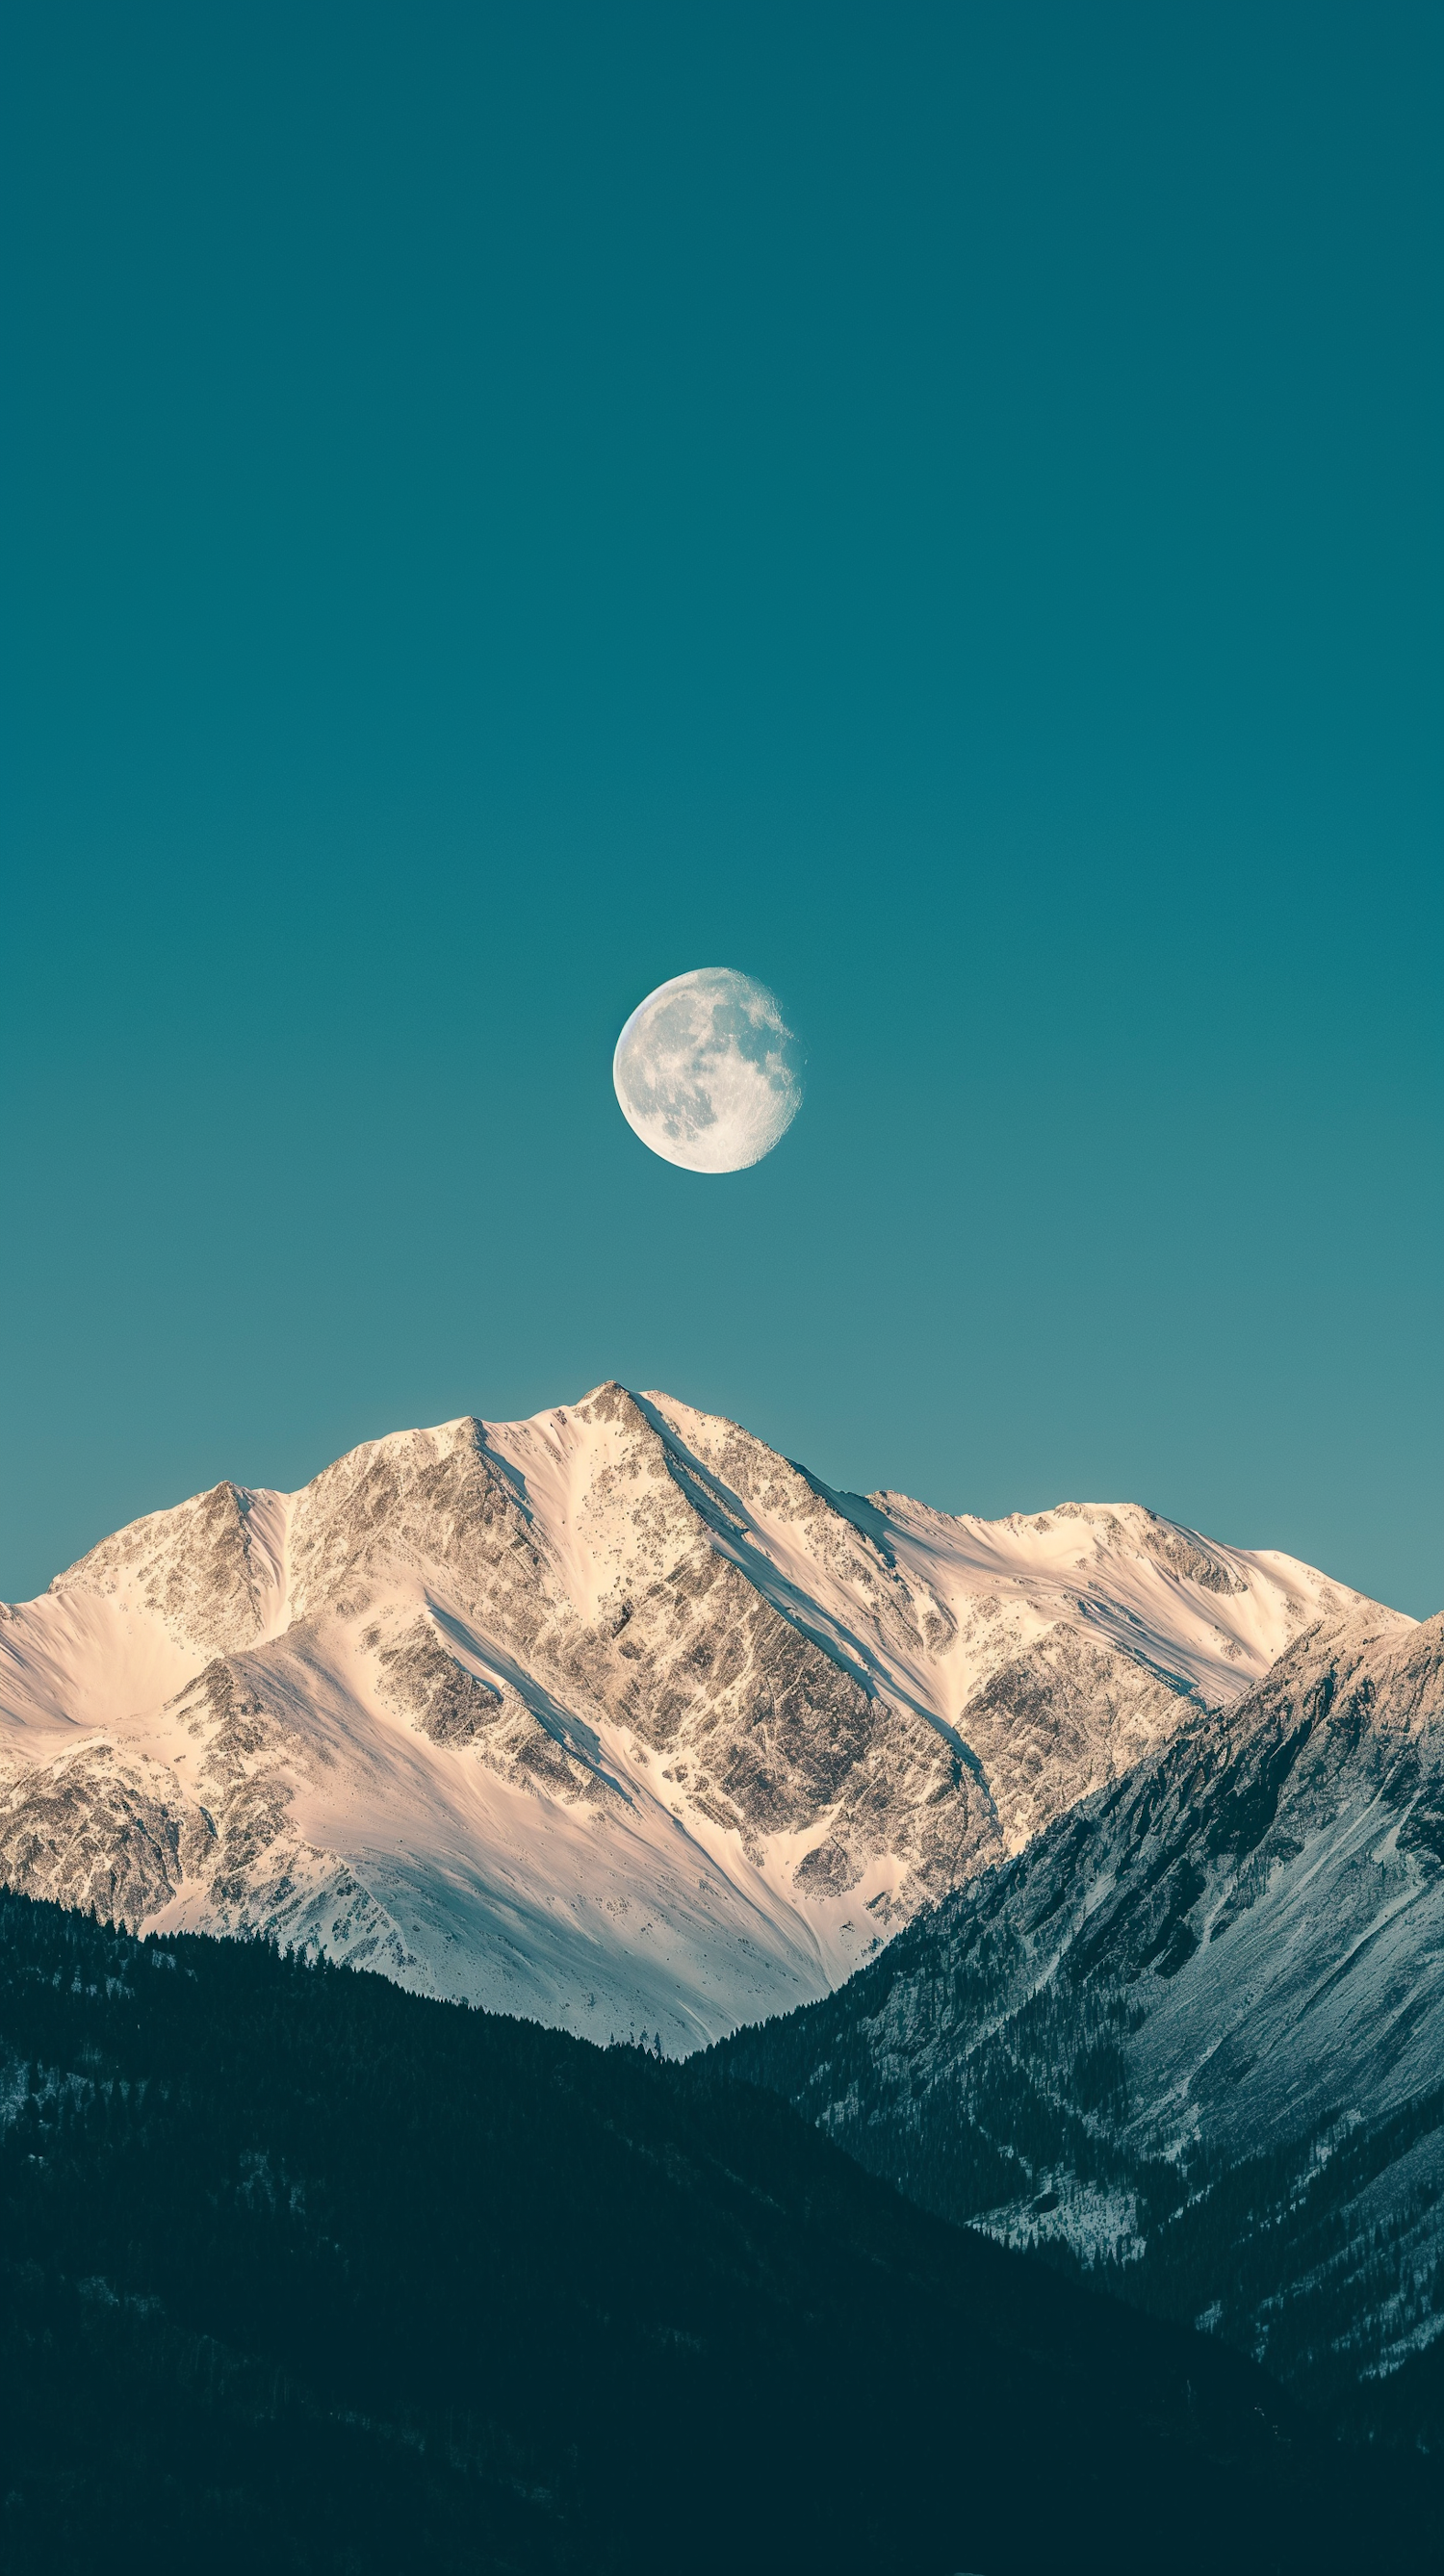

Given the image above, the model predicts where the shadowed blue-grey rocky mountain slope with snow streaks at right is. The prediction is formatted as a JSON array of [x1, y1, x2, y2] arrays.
[[731, 1608, 1444, 2406]]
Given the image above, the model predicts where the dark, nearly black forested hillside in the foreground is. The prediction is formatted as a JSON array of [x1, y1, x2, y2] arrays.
[[0, 1896, 1444, 2576]]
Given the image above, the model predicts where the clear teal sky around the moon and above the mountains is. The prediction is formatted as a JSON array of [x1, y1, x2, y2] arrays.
[[0, 0, 1444, 1612]]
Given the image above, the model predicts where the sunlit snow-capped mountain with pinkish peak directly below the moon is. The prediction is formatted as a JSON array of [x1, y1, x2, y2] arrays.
[[0, 1383, 1356, 2050]]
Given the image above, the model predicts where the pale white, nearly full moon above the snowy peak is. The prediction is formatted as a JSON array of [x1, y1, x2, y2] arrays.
[[612, 966, 806, 1172]]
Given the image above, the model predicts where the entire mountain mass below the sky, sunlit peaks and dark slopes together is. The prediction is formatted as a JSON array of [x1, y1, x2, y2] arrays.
[[0, 1386, 1444, 2576]]
